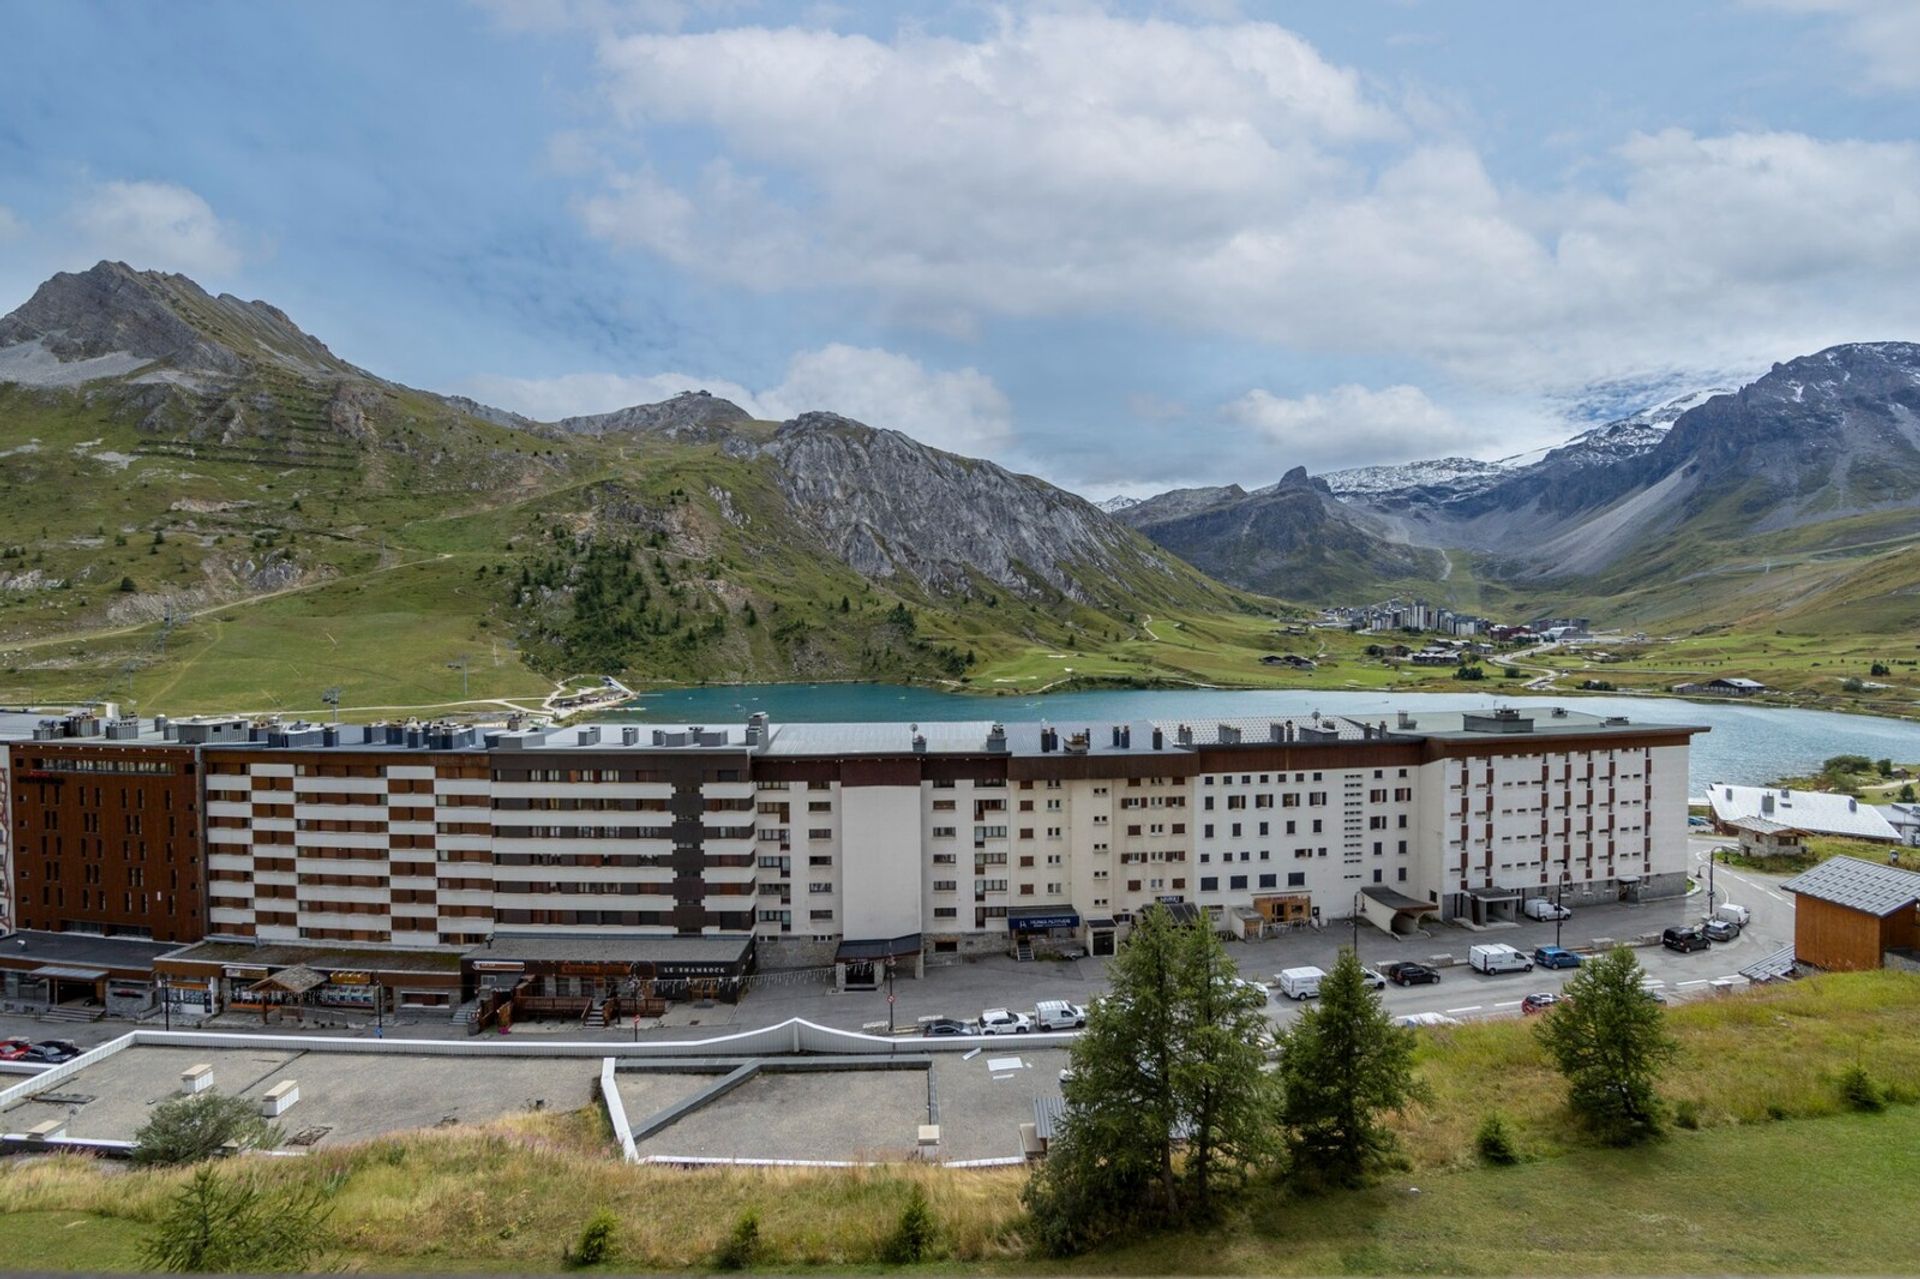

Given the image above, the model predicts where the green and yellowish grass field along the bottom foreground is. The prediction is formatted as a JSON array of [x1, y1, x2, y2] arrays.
[[0, 974, 1920, 1275]]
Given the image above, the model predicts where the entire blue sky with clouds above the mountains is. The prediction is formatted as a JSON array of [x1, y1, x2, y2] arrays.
[[0, 0, 1920, 499]]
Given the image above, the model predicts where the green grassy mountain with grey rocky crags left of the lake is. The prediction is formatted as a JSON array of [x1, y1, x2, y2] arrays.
[[0, 263, 1290, 711]]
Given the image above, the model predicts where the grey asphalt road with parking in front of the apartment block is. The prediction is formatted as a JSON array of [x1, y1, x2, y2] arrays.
[[0, 839, 1793, 1052]]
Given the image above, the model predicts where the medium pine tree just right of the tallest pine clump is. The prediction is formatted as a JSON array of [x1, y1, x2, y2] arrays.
[[1279, 949, 1423, 1185]]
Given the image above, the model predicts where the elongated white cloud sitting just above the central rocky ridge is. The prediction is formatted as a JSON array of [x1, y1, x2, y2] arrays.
[[468, 342, 1014, 453]]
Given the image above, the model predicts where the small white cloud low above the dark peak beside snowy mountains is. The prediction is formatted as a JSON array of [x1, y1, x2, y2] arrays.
[[1221, 384, 1488, 472]]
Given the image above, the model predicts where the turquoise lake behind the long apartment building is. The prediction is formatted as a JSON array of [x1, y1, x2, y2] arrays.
[[610, 684, 1920, 793]]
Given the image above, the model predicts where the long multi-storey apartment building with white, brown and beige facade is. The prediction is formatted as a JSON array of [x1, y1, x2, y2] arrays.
[[4, 711, 1701, 966]]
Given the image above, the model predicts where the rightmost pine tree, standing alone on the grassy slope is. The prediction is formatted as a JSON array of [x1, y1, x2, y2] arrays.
[[1536, 947, 1680, 1145]]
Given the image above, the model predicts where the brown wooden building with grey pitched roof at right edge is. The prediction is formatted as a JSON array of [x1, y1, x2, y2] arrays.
[[1780, 857, 1920, 972]]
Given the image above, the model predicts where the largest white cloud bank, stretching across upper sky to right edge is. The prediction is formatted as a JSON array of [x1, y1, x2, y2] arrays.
[[580, 0, 1920, 396]]
